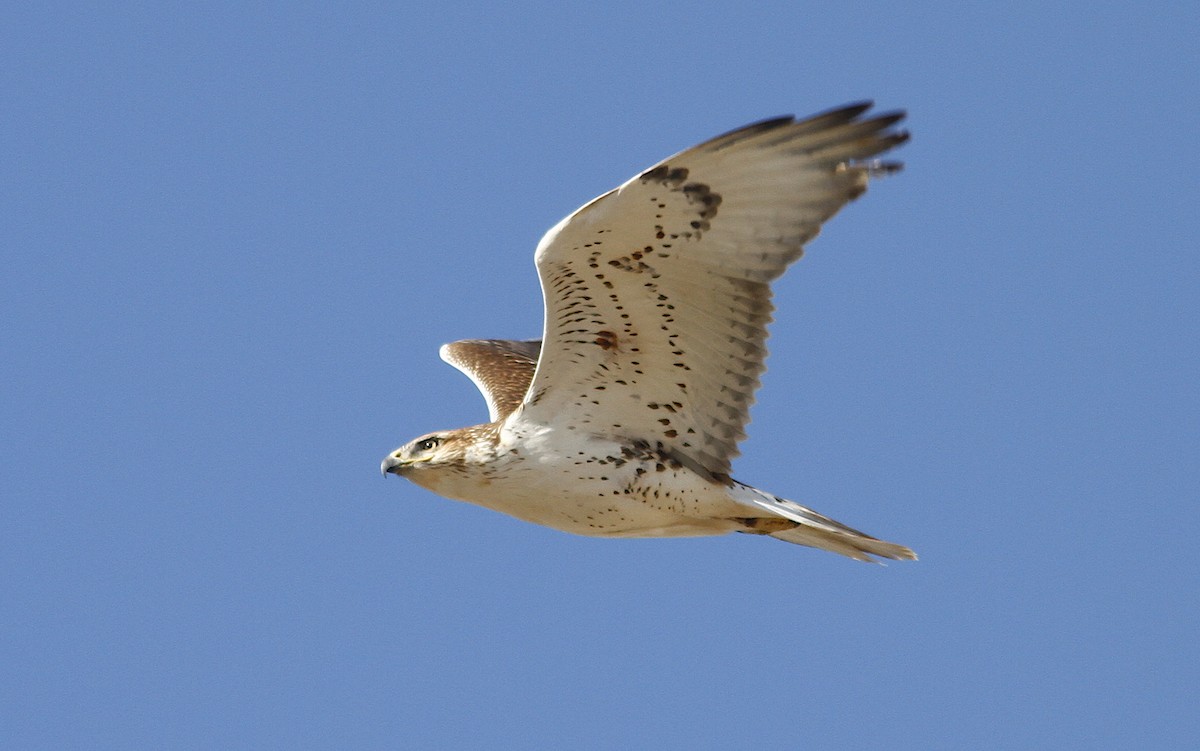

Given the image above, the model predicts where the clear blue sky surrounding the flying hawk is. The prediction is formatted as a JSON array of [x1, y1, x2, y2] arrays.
[[0, 1, 1200, 750]]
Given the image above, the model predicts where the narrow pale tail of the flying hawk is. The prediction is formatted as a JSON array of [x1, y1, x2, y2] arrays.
[[730, 480, 917, 563]]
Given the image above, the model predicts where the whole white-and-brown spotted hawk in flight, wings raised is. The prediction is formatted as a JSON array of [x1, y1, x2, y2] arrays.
[[380, 102, 917, 563]]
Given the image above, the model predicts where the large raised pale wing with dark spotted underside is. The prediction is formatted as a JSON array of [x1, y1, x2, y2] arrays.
[[512, 103, 908, 476]]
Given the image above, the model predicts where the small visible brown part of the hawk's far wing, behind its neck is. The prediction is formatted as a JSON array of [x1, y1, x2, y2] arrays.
[[438, 340, 541, 422]]
